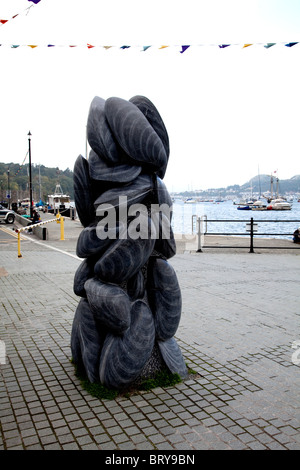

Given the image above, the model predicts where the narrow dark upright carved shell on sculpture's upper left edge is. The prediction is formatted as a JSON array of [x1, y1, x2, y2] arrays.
[[73, 155, 95, 227]]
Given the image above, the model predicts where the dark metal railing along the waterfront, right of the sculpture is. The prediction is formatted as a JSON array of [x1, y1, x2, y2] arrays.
[[192, 215, 300, 253]]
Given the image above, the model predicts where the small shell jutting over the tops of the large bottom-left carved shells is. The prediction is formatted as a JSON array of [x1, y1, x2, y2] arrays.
[[84, 278, 131, 335]]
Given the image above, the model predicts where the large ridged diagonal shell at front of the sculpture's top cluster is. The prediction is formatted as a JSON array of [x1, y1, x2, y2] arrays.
[[105, 97, 168, 170]]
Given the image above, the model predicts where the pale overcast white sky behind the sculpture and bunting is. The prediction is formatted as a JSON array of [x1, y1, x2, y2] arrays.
[[0, 0, 300, 191]]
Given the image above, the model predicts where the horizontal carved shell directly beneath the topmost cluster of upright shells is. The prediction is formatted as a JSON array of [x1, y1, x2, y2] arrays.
[[89, 150, 142, 183]]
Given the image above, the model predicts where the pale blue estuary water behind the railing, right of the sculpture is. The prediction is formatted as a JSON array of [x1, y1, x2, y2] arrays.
[[171, 199, 300, 239]]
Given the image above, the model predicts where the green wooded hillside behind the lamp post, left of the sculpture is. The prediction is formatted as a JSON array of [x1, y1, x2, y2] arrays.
[[0, 163, 74, 202]]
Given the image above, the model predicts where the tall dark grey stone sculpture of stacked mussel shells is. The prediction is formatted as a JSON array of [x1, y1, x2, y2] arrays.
[[71, 96, 187, 390]]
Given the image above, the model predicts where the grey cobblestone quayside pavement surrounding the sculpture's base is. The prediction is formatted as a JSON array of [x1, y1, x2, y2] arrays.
[[0, 226, 300, 452]]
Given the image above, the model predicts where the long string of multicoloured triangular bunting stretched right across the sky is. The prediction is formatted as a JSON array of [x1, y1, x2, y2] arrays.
[[0, 41, 299, 54]]
